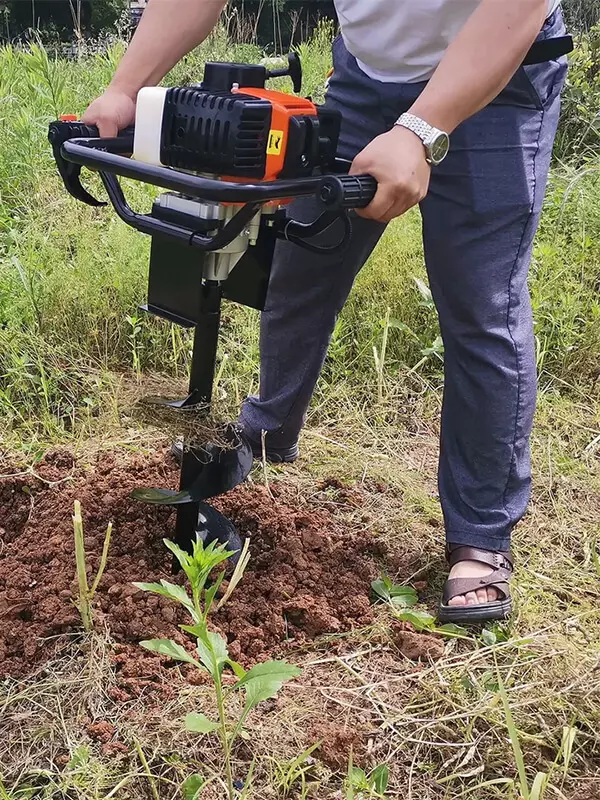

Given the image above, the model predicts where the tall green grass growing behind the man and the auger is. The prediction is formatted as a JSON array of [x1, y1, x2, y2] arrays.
[[0, 26, 600, 441]]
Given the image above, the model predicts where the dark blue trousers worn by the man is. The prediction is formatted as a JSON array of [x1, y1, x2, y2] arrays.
[[241, 12, 567, 550]]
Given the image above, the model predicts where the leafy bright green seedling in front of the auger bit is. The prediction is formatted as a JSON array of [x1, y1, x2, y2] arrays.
[[134, 536, 300, 800]]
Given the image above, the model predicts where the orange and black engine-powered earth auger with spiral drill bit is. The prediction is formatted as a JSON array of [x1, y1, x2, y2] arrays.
[[49, 54, 377, 564]]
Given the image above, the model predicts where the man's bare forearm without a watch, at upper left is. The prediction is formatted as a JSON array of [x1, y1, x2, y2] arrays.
[[110, 0, 227, 98]]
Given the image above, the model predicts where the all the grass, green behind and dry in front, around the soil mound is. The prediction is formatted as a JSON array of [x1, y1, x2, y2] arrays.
[[0, 15, 600, 800]]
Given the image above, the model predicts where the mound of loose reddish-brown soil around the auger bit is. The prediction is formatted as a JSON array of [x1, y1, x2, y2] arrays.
[[0, 452, 381, 699]]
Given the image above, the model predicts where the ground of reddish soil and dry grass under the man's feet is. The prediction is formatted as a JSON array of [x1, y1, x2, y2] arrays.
[[0, 404, 600, 800]]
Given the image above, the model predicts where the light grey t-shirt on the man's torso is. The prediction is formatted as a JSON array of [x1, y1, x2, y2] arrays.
[[335, 0, 560, 83]]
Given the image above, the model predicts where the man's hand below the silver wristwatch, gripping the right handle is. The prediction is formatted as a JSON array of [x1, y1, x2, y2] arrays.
[[350, 126, 431, 222]]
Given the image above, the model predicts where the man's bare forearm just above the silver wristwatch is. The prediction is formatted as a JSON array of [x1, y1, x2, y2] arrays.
[[412, 0, 548, 133]]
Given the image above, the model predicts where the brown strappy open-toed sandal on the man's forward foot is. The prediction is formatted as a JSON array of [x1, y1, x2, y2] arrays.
[[438, 544, 513, 623]]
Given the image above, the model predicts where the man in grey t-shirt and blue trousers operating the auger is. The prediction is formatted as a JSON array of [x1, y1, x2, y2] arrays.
[[84, 0, 566, 622]]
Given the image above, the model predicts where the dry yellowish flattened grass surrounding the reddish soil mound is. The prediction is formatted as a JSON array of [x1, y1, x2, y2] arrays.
[[0, 386, 600, 800]]
